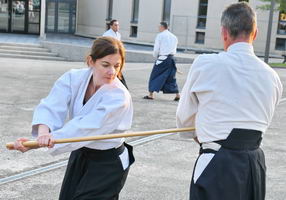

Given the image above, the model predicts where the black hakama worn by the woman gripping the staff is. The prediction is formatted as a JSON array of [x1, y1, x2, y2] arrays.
[[59, 143, 134, 200]]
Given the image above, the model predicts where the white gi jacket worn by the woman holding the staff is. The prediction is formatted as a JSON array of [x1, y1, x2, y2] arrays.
[[32, 68, 133, 155]]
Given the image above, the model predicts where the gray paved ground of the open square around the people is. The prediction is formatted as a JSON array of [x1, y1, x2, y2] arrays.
[[0, 58, 286, 200]]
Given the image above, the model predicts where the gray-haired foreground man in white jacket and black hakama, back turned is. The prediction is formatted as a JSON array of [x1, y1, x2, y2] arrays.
[[177, 3, 282, 200]]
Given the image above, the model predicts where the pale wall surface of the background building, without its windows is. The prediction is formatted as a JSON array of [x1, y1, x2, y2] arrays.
[[76, 0, 286, 54]]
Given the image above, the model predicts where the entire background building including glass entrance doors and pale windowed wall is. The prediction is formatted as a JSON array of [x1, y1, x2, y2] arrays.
[[0, 0, 286, 55]]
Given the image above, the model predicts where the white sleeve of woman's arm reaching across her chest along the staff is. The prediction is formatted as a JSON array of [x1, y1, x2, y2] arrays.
[[50, 89, 132, 155]]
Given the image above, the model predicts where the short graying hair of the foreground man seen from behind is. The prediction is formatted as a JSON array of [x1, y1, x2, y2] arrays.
[[221, 2, 256, 39]]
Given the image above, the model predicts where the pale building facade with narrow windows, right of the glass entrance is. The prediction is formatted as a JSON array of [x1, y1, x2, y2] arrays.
[[75, 0, 286, 55]]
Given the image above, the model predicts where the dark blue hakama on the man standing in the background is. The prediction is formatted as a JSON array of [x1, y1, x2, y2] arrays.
[[149, 55, 179, 93]]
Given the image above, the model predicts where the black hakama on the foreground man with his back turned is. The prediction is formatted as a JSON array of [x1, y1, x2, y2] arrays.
[[190, 129, 266, 200]]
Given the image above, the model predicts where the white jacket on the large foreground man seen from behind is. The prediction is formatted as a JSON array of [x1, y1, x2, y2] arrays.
[[176, 42, 282, 143]]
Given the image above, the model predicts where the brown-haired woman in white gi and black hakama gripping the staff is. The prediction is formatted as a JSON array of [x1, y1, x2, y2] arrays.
[[14, 37, 134, 200]]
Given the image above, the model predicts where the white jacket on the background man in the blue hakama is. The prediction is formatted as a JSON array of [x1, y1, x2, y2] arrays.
[[153, 30, 178, 60]]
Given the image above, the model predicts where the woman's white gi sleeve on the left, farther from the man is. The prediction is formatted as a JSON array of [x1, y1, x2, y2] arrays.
[[32, 72, 71, 137]]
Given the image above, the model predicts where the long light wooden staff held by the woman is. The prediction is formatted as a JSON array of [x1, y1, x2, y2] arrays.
[[6, 127, 195, 150]]
